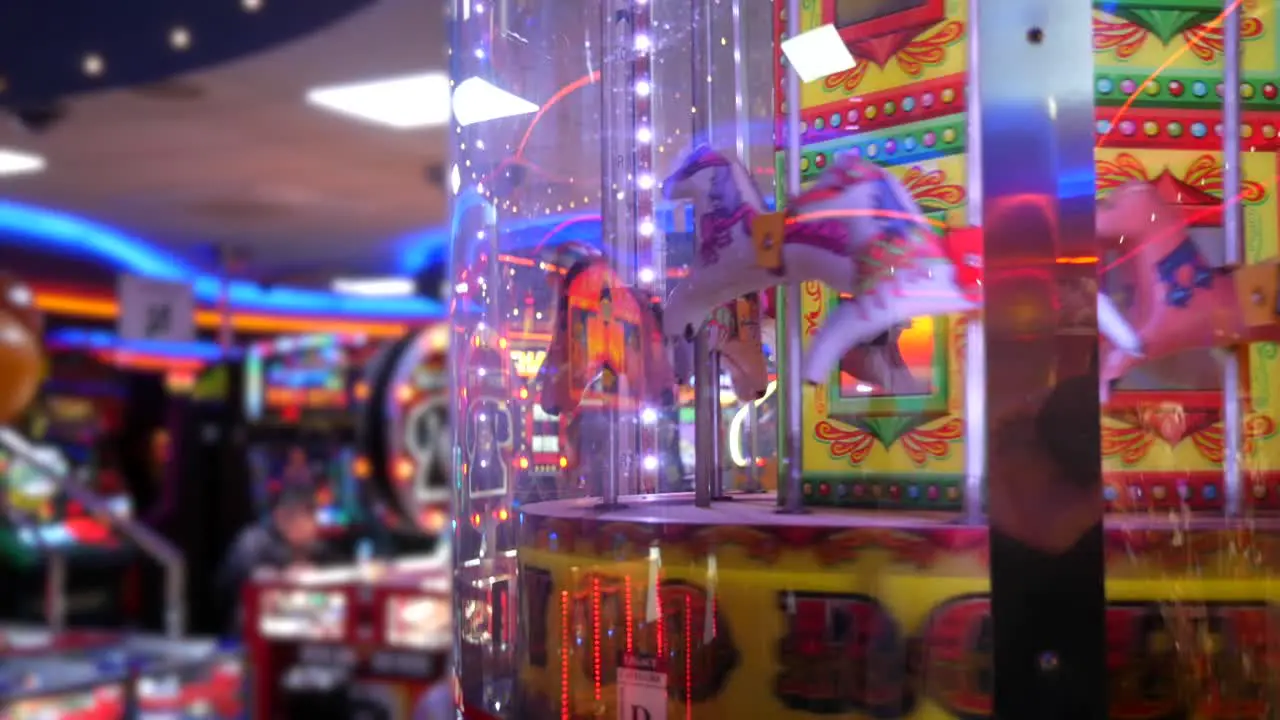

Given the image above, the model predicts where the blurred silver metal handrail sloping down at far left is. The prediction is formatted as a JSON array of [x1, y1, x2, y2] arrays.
[[0, 427, 187, 639]]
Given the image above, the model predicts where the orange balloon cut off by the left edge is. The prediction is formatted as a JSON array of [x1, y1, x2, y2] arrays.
[[0, 273, 44, 424]]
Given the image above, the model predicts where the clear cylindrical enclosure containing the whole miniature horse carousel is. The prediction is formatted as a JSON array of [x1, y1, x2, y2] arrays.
[[449, 0, 1280, 720]]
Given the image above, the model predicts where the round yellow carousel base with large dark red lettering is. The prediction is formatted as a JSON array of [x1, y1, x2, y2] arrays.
[[517, 495, 1280, 720]]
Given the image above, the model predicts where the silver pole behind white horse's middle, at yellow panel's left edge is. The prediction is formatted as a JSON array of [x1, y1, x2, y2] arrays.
[[781, 0, 805, 512]]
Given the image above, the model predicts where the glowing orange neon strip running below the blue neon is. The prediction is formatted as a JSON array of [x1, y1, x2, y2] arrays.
[[36, 290, 410, 338]]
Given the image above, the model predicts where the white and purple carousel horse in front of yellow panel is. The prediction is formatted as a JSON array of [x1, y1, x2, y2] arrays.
[[663, 147, 975, 383]]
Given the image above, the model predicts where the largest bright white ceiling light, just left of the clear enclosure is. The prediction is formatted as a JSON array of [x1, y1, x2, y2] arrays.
[[307, 73, 449, 129]]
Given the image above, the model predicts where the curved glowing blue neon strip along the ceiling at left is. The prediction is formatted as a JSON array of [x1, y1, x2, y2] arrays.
[[0, 200, 445, 320]]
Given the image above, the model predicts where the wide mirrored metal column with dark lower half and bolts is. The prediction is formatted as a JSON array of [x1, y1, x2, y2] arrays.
[[970, 0, 1107, 720]]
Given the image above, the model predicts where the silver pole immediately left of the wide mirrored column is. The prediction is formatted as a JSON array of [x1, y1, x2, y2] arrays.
[[963, 0, 987, 525]]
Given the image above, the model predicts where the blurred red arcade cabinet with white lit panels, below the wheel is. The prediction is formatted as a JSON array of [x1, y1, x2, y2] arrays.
[[244, 553, 452, 720]]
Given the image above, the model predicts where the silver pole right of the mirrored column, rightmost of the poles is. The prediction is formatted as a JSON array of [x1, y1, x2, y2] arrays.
[[1222, 0, 1249, 516]]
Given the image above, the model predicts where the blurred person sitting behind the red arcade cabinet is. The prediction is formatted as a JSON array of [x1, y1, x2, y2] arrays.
[[216, 486, 340, 625]]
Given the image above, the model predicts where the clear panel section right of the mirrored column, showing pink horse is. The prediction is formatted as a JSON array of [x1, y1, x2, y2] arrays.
[[1094, 0, 1280, 717]]
